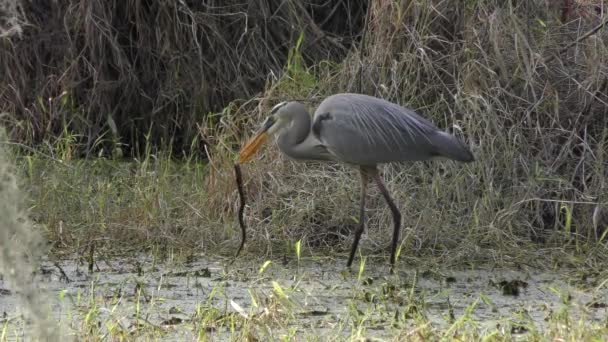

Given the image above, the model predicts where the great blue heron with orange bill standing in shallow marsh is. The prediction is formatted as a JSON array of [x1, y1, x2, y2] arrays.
[[239, 94, 474, 270]]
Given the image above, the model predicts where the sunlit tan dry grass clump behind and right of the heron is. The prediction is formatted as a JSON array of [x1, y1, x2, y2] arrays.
[[202, 1, 608, 262]]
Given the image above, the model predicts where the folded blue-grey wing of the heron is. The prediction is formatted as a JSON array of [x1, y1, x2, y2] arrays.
[[313, 94, 442, 165]]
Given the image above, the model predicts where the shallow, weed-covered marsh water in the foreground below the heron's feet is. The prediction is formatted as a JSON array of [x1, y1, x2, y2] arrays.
[[0, 256, 608, 340]]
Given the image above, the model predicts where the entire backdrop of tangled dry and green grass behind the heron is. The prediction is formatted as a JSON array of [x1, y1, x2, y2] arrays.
[[0, 0, 608, 263]]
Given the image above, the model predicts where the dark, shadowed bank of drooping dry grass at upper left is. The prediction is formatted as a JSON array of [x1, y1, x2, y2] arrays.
[[0, 0, 364, 156]]
